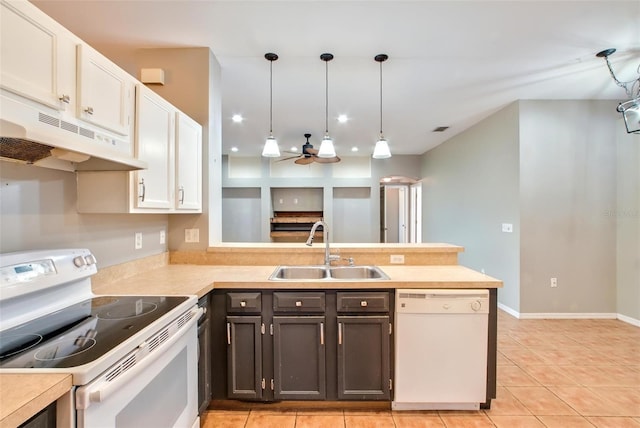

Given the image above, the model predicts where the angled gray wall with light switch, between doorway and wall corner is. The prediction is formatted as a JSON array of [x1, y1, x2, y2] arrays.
[[422, 103, 520, 311]]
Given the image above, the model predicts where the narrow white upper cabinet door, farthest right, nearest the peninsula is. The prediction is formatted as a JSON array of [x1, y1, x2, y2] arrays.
[[175, 112, 202, 212]]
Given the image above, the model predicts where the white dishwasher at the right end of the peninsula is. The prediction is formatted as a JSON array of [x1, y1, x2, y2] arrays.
[[391, 289, 489, 410]]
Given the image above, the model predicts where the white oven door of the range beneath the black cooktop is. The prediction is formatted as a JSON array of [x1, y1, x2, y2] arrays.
[[76, 309, 202, 428]]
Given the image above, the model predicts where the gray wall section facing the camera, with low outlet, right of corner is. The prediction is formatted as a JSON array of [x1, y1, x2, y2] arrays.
[[520, 101, 617, 313]]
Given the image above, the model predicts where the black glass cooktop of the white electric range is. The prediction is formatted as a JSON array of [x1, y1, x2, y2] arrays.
[[0, 296, 187, 368]]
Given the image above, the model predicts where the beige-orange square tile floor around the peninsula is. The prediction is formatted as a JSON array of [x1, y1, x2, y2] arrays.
[[201, 311, 640, 428]]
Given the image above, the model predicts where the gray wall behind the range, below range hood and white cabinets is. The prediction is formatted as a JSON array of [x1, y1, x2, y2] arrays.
[[0, 162, 169, 267]]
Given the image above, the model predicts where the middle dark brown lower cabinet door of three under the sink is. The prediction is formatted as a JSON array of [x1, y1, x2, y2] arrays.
[[273, 316, 327, 400]]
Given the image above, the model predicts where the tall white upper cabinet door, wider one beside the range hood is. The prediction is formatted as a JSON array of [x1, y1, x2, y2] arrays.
[[133, 85, 176, 209]]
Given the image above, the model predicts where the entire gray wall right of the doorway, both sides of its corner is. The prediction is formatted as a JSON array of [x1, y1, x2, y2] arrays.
[[423, 101, 640, 320]]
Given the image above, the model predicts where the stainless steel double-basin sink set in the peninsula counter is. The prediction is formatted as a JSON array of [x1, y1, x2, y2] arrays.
[[269, 265, 389, 281]]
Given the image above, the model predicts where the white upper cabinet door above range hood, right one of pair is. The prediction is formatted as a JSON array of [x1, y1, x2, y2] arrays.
[[77, 45, 133, 136]]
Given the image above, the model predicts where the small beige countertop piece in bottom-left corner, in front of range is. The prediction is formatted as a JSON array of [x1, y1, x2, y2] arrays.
[[0, 373, 71, 428]]
